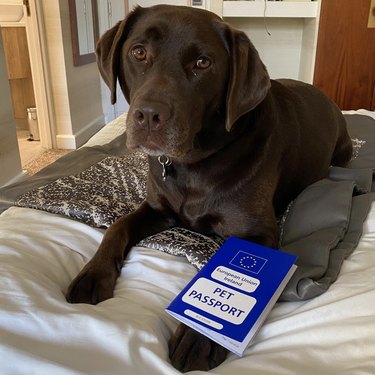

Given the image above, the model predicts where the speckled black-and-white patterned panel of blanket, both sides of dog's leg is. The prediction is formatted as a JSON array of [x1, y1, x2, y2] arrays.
[[16, 152, 223, 269]]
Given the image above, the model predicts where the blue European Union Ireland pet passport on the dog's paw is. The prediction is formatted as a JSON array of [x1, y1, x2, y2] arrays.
[[166, 237, 297, 356]]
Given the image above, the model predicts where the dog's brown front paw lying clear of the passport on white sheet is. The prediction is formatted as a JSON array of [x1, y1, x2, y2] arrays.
[[66, 263, 118, 305]]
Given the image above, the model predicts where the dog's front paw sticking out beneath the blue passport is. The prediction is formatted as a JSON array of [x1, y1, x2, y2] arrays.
[[169, 324, 228, 372]]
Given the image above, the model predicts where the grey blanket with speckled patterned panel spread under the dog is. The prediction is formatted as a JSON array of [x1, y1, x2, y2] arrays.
[[0, 115, 375, 300]]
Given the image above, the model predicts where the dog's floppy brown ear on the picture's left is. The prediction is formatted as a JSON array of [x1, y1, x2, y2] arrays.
[[96, 7, 143, 104]]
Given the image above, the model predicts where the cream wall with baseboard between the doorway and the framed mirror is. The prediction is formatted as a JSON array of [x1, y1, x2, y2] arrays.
[[42, 0, 104, 149]]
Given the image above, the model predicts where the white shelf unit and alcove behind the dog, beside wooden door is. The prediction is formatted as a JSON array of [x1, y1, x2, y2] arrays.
[[220, 0, 320, 83]]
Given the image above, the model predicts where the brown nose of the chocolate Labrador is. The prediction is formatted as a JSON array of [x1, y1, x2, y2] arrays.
[[133, 103, 171, 130]]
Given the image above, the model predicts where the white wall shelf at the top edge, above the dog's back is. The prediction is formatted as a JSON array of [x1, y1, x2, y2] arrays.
[[223, 0, 318, 18]]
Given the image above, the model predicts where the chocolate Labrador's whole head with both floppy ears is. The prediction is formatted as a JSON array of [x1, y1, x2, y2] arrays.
[[97, 5, 270, 160]]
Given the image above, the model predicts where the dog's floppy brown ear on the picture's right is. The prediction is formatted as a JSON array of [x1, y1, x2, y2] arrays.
[[225, 28, 271, 131]]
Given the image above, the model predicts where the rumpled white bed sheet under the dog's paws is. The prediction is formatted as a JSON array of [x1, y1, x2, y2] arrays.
[[0, 114, 375, 375]]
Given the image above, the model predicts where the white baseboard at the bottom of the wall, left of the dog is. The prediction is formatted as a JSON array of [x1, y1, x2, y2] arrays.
[[56, 116, 105, 150]]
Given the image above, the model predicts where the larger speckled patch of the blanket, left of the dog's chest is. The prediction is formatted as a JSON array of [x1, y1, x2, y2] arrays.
[[16, 152, 148, 228]]
